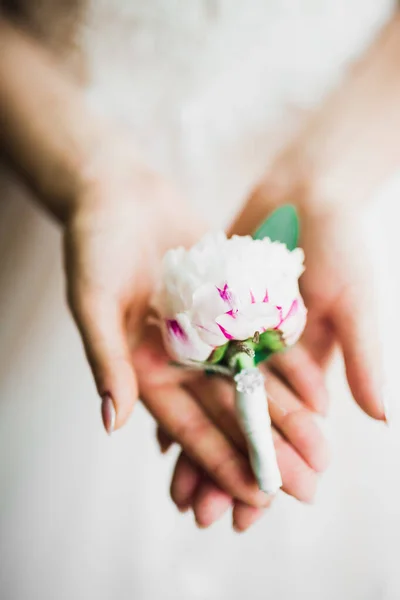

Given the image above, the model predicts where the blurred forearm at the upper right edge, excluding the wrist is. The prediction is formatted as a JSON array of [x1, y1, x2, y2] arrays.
[[296, 13, 400, 206]]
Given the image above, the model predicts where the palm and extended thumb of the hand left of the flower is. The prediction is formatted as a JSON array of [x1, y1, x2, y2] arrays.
[[64, 146, 202, 433]]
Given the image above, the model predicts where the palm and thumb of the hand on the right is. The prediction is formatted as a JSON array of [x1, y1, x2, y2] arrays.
[[294, 204, 384, 418]]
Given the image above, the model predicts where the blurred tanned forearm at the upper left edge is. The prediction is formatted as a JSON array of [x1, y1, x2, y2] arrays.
[[0, 19, 101, 217]]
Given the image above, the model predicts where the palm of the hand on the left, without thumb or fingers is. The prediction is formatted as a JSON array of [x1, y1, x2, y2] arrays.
[[65, 173, 196, 321]]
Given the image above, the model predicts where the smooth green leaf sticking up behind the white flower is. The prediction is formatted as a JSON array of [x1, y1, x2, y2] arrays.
[[253, 204, 299, 250]]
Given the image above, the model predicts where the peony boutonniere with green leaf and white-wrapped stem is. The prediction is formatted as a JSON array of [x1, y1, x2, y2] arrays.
[[155, 206, 307, 494]]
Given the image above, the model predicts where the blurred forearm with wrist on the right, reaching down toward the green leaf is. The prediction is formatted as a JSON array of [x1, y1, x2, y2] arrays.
[[233, 13, 400, 228]]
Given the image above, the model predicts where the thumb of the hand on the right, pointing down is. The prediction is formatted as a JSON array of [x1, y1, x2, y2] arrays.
[[333, 288, 385, 420]]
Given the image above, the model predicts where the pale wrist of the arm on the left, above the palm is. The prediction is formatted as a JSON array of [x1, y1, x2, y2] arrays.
[[67, 139, 207, 250]]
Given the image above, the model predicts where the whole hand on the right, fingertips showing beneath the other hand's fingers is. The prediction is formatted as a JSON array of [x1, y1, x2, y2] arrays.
[[164, 166, 385, 531]]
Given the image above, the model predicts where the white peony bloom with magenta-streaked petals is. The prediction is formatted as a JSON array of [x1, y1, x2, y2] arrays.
[[155, 232, 306, 361]]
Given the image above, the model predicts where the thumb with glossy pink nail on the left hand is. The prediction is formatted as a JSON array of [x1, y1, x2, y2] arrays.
[[70, 292, 138, 435]]
